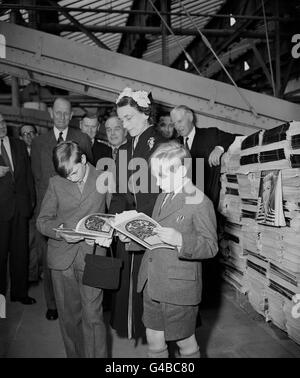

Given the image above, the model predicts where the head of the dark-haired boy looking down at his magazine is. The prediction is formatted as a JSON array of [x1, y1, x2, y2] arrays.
[[52, 141, 83, 178]]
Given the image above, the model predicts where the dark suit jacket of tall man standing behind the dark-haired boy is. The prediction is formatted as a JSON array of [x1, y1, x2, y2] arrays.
[[31, 127, 93, 212]]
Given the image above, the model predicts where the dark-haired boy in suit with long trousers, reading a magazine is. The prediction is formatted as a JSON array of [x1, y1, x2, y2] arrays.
[[37, 141, 110, 358]]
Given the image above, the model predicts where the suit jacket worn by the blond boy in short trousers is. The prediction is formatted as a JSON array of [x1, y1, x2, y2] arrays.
[[138, 183, 218, 305]]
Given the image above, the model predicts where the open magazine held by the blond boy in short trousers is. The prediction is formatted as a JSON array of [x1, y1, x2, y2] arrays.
[[110, 210, 174, 250]]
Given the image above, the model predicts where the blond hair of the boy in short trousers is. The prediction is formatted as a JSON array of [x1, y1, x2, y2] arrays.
[[150, 140, 191, 171]]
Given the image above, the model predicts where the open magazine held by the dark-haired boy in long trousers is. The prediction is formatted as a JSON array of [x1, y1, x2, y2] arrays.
[[54, 213, 115, 239]]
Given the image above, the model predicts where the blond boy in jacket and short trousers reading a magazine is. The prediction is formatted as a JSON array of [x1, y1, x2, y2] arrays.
[[138, 141, 218, 358]]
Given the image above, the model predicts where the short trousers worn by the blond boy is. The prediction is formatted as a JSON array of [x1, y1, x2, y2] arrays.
[[143, 285, 198, 341]]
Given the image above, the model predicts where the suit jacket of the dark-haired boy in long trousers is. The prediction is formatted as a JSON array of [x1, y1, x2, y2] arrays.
[[37, 164, 105, 270]]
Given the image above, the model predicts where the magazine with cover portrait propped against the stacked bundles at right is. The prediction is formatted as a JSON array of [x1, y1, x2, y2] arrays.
[[256, 169, 286, 227]]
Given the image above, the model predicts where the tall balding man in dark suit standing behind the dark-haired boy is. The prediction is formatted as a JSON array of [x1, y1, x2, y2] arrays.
[[31, 97, 92, 320]]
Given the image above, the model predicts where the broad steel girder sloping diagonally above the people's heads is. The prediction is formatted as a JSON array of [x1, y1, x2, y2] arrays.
[[0, 22, 300, 134]]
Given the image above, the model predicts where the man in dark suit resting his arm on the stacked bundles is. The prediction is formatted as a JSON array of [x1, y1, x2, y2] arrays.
[[170, 105, 235, 209]]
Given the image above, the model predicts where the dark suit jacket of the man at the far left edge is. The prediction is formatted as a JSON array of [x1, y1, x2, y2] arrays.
[[0, 138, 34, 221]]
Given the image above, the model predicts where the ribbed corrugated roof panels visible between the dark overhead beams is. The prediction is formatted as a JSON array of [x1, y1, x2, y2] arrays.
[[0, 0, 225, 75]]
